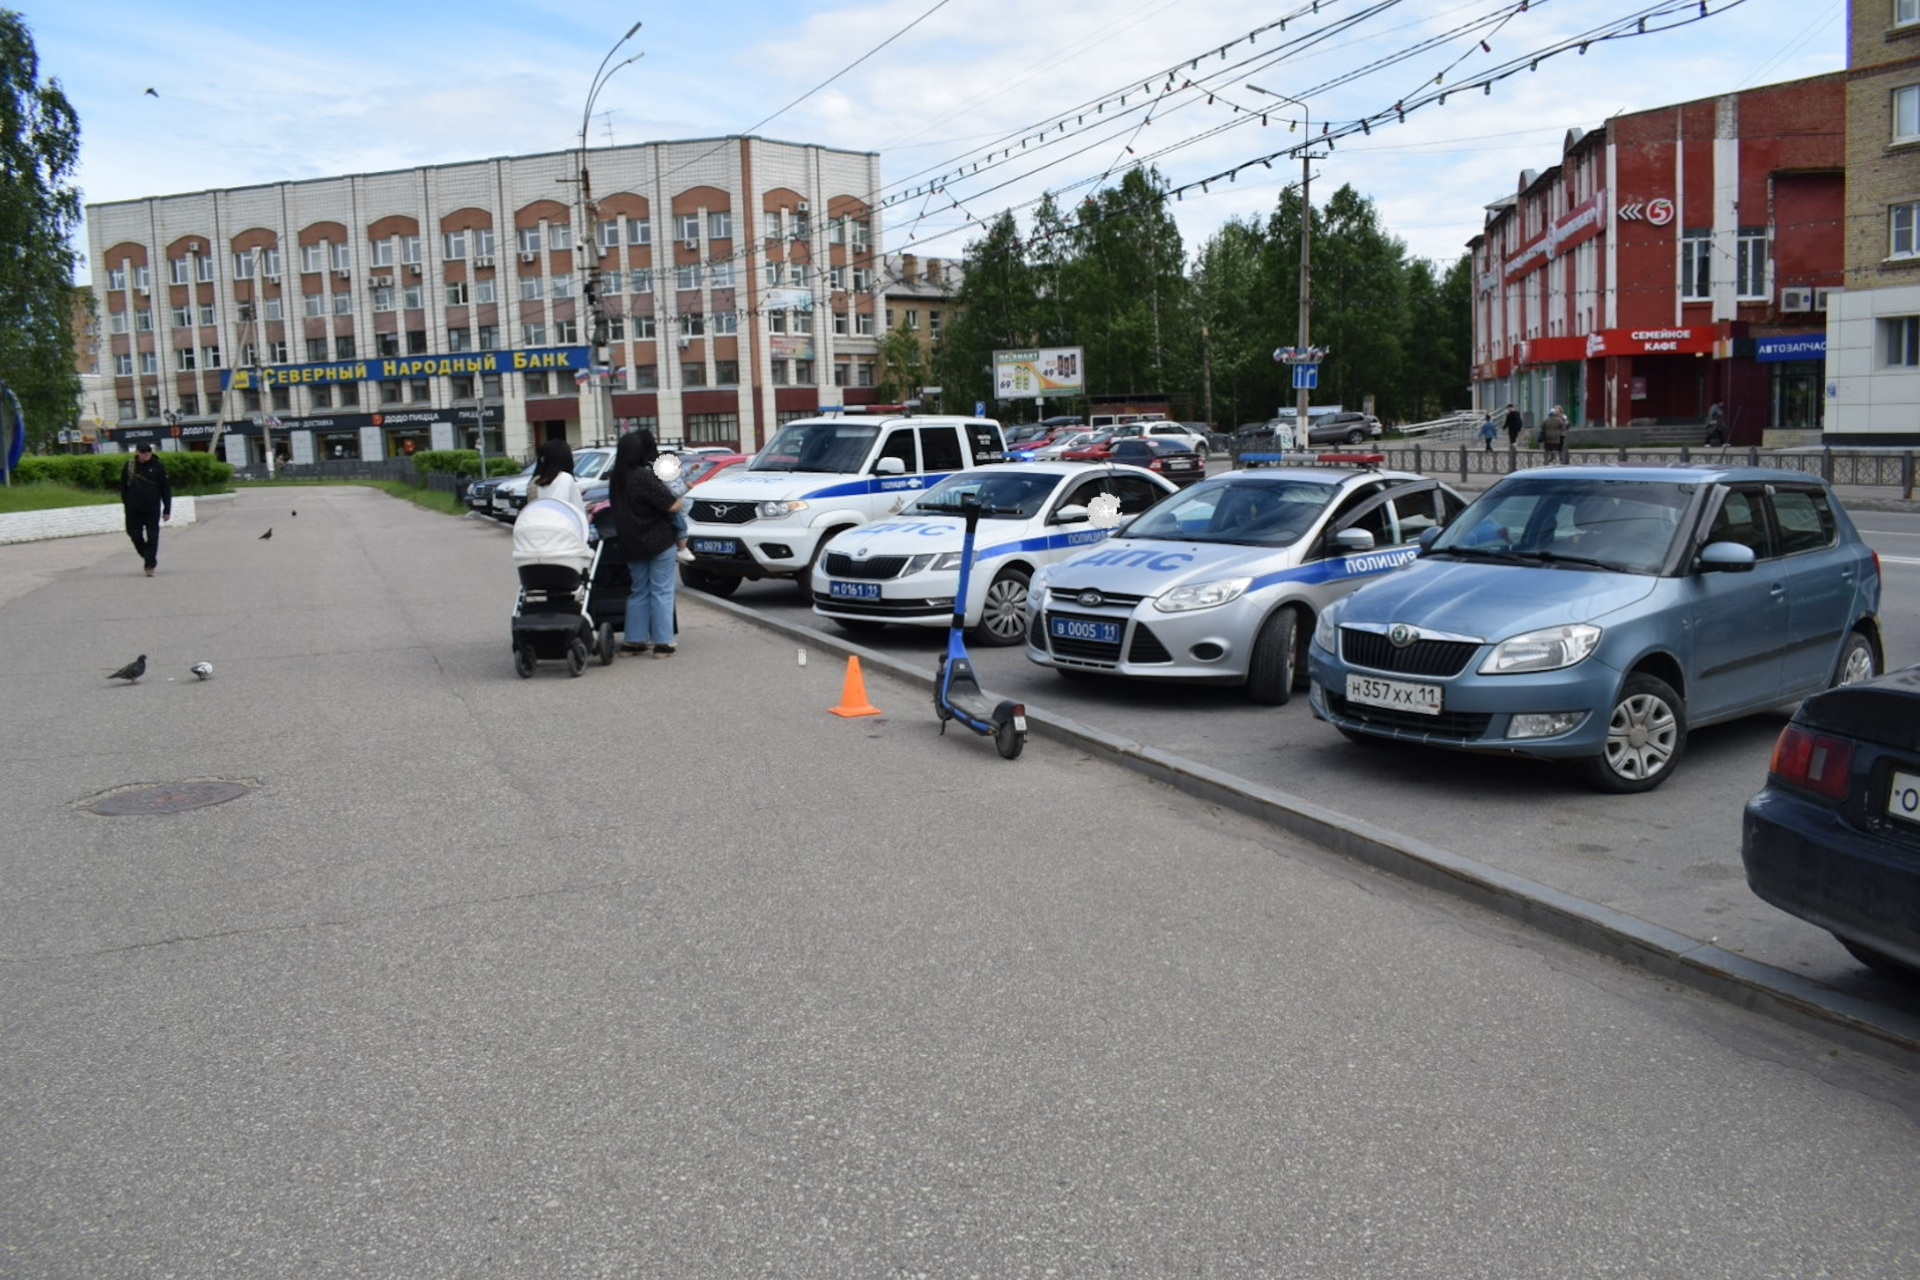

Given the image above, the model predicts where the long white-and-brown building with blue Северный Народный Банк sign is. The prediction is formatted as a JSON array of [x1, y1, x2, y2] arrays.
[[86, 138, 881, 462]]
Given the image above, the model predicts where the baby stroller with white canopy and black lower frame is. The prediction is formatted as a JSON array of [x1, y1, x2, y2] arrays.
[[513, 497, 612, 679]]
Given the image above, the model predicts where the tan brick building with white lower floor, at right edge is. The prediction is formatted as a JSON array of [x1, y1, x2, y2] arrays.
[[1826, 0, 1920, 447]]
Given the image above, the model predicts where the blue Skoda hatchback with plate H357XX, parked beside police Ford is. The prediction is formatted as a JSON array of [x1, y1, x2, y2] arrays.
[[1309, 466, 1884, 791]]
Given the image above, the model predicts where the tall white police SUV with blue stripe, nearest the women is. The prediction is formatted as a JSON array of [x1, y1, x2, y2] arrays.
[[680, 415, 1006, 595]]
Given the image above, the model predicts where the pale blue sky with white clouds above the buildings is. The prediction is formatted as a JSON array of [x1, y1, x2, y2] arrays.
[[17, 0, 1847, 278]]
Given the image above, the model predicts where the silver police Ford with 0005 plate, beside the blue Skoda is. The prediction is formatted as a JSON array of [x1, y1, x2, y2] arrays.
[[1027, 466, 1465, 706]]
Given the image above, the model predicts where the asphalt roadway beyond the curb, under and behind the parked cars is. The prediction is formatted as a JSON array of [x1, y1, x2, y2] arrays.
[[702, 510, 1920, 1013]]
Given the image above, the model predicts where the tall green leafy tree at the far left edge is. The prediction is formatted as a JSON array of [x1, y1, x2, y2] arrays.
[[0, 10, 81, 445]]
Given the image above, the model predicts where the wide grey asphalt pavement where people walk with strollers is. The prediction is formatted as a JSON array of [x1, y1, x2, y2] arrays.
[[0, 487, 1920, 1280]]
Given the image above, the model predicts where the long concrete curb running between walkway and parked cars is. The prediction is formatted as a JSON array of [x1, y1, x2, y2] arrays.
[[687, 591, 1920, 1071]]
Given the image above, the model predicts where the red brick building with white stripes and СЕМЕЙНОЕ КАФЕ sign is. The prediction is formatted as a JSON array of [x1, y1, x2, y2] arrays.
[[1469, 73, 1845, 443]]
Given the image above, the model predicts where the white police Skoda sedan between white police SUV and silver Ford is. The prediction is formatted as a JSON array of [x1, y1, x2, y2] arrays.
[[812, 462, 1175, 645]]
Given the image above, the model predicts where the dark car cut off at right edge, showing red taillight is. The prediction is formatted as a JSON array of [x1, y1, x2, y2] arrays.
[[1740, 666, 1920, 983]]
